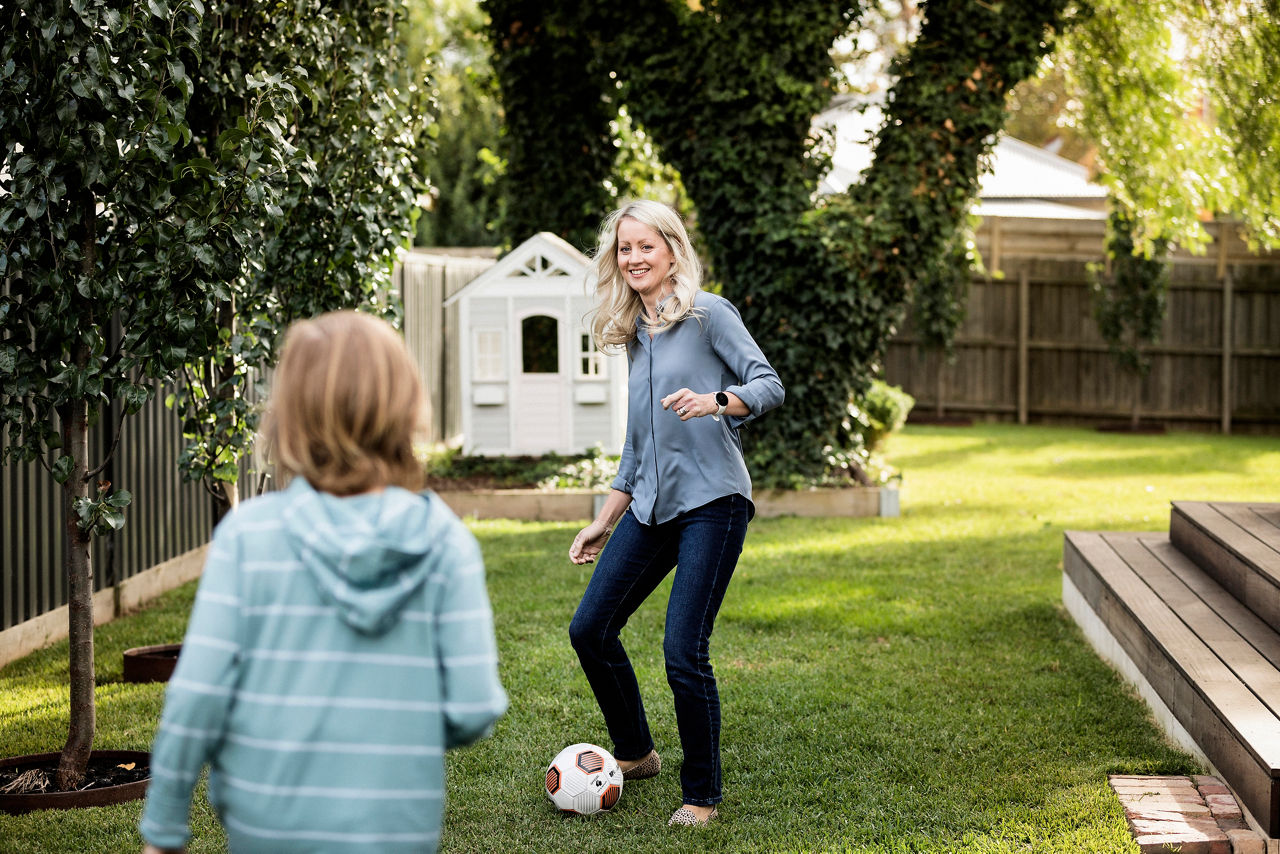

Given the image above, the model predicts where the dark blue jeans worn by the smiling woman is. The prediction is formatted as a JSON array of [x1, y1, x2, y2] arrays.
[[568, 495, 750, 807]]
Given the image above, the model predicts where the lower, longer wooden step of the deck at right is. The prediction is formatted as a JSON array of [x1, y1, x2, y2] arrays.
[[1062, 531, 1280, 836]]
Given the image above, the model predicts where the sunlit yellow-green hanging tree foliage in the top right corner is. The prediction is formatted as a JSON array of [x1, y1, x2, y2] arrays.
[[1056, 0, 1280, 255]]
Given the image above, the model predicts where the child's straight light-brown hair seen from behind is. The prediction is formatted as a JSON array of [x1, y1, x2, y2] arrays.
[[265, 311, 426, 495]]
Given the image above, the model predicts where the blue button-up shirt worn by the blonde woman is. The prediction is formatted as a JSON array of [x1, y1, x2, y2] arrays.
[[613, 291, 783, 525]]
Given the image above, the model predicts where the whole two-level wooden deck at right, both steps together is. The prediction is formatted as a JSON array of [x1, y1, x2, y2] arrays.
[[1064, 502, 1280, 837]]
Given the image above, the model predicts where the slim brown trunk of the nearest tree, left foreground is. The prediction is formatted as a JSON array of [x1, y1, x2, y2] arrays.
[[58, 391, 96, 791]]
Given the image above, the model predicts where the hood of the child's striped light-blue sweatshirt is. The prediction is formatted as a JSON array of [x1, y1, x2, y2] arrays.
[[277, 478, 452, 635]]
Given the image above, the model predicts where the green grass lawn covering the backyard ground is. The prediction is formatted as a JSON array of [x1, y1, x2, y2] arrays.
[[0, 425, 1280, 854]]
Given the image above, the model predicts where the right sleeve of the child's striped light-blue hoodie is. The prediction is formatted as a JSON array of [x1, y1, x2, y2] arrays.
[[435, 524, 507, 748]]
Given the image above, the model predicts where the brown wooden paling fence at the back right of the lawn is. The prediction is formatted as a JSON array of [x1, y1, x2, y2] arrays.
[[884, 219, 1280, 433]]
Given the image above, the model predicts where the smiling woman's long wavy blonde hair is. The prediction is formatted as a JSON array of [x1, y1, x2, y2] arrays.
[[588, 198, 703, 350]]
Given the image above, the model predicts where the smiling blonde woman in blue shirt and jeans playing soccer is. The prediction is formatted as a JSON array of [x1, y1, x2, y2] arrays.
[[568, 201, 783, 825]]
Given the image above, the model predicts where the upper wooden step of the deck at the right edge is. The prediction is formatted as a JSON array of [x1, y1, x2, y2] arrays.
[[1169, 501, 1280, 630]]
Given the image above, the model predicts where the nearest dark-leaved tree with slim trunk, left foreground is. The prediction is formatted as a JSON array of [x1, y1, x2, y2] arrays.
[[0, 0, 296, 789]]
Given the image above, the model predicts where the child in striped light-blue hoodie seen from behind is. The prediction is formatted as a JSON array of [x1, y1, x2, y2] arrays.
[[140, 311, 507, 854]]
